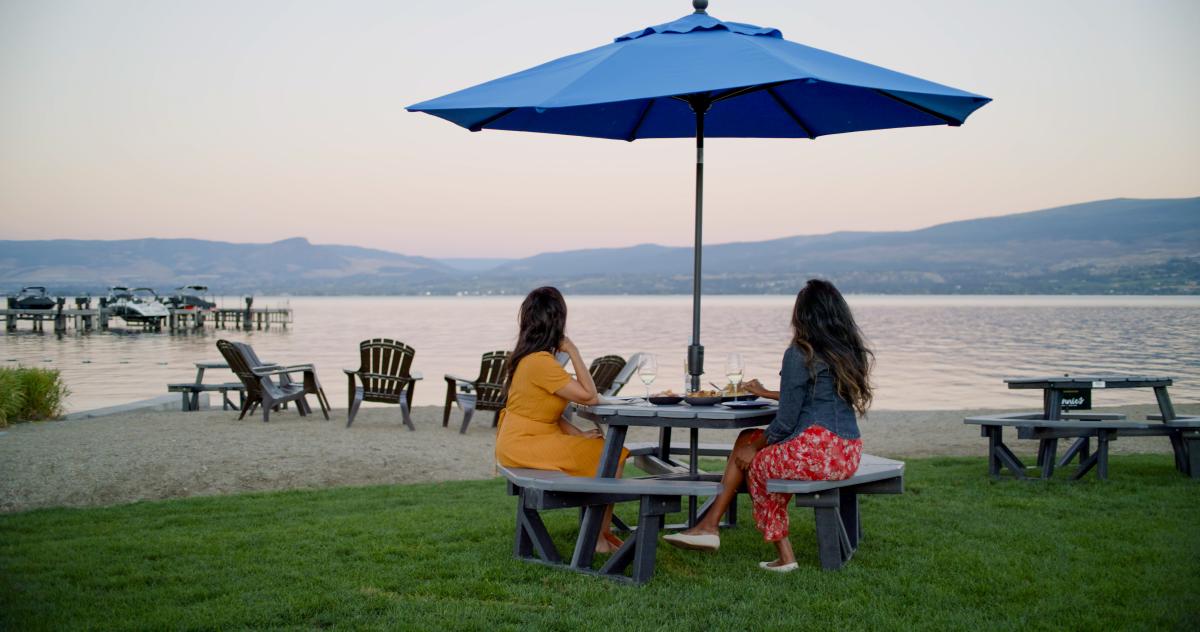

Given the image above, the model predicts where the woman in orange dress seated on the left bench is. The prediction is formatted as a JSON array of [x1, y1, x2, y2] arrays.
[[496, 288, 629, 553]]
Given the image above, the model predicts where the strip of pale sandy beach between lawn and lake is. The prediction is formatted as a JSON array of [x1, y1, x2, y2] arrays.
[[0, 405, 1185, 512]]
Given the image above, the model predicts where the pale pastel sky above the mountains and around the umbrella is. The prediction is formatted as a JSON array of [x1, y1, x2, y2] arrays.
[[0, 0, 1200, 257]]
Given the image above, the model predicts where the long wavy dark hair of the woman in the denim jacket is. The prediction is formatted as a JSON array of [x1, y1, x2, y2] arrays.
[[792, 278, 875, 415]]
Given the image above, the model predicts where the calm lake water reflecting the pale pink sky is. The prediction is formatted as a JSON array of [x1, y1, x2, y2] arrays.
[[0, 296, 1200, 410]]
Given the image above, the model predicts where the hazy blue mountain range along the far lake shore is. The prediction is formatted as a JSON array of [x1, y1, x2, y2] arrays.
[[0, 198, 1200, 295]]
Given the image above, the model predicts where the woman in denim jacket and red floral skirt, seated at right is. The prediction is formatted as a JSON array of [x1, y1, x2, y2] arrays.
[[664, 279, 874, 572]]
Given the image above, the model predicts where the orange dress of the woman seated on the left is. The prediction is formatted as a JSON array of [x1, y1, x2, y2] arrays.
[[496, 351, 629, 476]]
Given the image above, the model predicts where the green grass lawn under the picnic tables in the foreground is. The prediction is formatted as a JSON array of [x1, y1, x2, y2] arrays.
[[0, 456, 1200, 630]]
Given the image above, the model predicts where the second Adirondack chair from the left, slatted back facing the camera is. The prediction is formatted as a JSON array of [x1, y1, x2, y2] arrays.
[[343, 338, 422, 431]]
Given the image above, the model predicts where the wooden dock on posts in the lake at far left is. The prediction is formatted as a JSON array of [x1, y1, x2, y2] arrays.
[[0, 299, 293, 333]]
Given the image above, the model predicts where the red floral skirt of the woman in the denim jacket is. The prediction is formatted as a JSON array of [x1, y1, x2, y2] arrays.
[[746, 426, 863, 542]]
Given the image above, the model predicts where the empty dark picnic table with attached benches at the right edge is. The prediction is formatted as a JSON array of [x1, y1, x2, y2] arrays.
[[964, 374, 1196, 480]]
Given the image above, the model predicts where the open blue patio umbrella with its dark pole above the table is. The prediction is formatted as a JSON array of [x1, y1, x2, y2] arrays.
[[408, 0, 991, 390]]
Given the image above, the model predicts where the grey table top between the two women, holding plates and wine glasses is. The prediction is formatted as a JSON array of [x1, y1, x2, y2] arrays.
[[578, 404, 779, 428]]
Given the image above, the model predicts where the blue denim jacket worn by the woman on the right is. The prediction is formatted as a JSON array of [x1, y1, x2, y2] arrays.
[[767, 345, 860, 444]]
